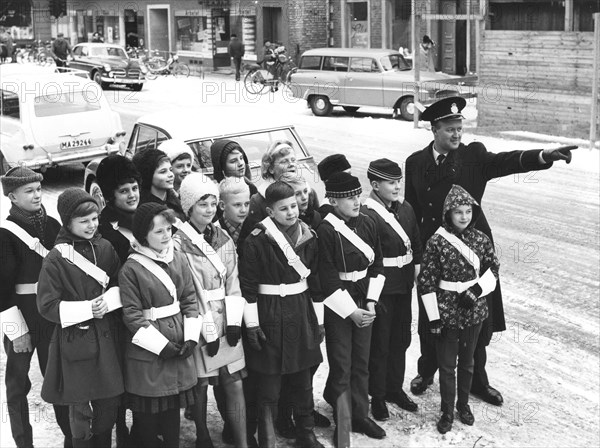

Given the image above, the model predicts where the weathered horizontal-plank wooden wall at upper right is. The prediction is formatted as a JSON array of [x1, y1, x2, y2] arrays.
[[477, 31, 594, 138]]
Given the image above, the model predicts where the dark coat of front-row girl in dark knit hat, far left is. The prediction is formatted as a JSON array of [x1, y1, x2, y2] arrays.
[[37, 227, 124, 404]]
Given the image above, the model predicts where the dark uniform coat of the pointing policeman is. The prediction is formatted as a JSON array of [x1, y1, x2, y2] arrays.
[[405, 142, 552, 331]]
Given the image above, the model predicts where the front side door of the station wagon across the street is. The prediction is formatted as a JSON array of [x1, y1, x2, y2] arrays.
[[342, 57, 383, 107]]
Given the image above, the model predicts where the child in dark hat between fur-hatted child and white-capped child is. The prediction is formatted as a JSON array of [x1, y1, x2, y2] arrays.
[[132, 149, 185, 222]]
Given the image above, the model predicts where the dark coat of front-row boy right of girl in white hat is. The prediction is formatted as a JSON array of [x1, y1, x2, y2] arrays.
[[239, 222, 323, 375]]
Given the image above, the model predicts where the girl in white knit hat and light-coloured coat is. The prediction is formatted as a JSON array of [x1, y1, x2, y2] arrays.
[[173, 173, 248, 448]]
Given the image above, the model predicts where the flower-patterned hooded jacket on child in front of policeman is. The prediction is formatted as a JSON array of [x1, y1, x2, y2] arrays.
[[418, 186, 500, 329]]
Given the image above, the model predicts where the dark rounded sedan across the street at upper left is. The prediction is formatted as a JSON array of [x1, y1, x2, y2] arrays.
[[69, 42, 146, 91]]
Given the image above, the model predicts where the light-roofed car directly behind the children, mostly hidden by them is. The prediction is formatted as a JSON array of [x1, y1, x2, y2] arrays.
[[84, 106, 325, 207]]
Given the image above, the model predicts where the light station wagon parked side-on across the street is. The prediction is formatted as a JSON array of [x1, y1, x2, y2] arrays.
[[290, 48, 475, 120]]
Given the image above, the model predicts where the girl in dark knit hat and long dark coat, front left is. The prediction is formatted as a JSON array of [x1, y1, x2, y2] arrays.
[[38, 188, 124, 448]]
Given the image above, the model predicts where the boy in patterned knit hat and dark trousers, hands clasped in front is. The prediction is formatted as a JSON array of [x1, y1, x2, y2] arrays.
[[317, 172, 385, 447]]
